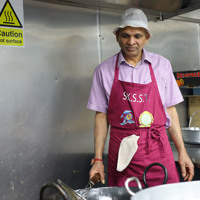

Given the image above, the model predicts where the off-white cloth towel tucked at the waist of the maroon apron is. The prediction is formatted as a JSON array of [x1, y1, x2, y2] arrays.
[[117, 135, 140, 172]]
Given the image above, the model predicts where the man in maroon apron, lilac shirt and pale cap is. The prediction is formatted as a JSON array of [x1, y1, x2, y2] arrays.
[[88, 8, 194, 186]]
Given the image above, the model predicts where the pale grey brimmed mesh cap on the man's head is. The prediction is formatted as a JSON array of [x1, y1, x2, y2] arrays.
[[113, 8, 151, 35]]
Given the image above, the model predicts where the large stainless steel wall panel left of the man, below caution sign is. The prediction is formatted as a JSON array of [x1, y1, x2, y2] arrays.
[[0, 1, 98, 200]]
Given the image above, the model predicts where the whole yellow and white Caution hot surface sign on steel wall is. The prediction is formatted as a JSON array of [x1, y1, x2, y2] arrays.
[[0, 0, 24, 47]]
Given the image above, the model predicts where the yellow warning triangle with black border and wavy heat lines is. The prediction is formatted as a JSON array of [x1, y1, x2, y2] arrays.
[[0, 0, 22, 28]]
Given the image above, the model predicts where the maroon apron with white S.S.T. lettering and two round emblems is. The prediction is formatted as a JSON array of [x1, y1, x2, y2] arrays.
[[108, 53, 179, 187]]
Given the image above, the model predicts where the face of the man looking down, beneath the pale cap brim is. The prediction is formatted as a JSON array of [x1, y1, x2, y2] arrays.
[[116, 26, 150, 59]]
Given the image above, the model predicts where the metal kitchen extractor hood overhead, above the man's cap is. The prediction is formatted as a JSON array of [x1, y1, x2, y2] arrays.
[[33, 0, 200, 20]]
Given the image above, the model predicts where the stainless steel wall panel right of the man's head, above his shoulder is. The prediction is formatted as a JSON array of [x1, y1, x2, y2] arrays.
[[147, 20, 200, 71]]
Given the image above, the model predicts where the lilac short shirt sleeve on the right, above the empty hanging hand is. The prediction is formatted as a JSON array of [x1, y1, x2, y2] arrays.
[[165, 62, 183, 107]]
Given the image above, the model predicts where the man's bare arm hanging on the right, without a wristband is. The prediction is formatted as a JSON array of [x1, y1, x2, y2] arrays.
[[166, 106, 194, 181]]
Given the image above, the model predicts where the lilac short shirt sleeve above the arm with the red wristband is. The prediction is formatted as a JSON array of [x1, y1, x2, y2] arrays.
[[87, 66, 108, 113]]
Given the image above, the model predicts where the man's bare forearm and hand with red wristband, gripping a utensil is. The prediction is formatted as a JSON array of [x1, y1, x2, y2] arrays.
[[90, 112, 108, 184]]
